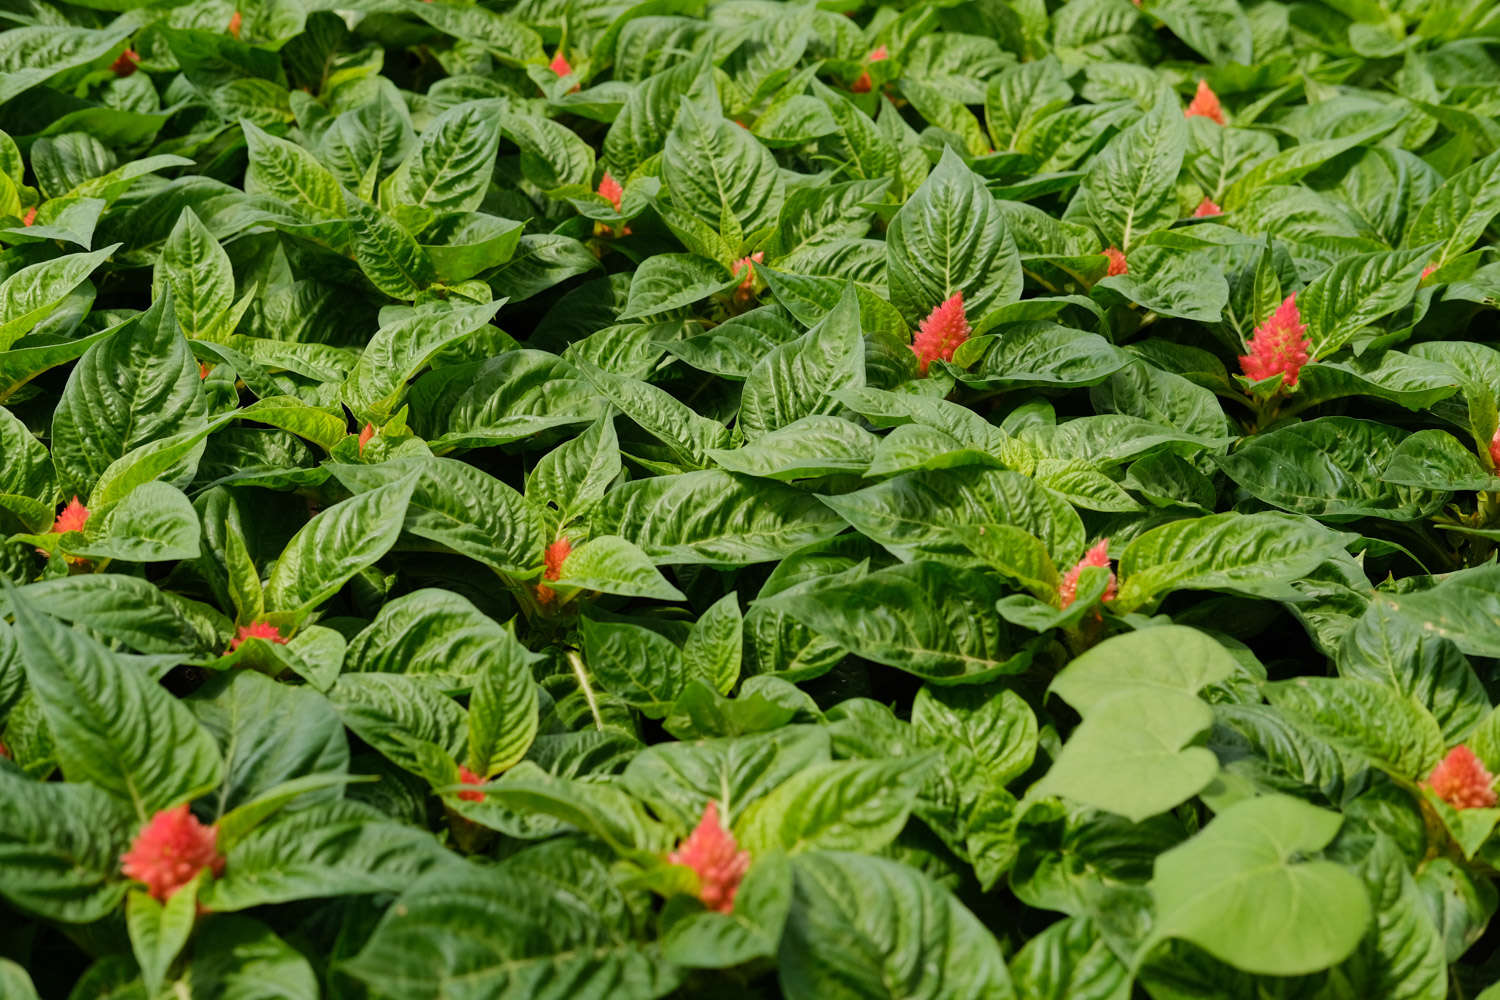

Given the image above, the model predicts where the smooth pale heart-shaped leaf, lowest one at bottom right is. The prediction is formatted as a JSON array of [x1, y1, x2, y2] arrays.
[[1151, 795, 1370, 976]]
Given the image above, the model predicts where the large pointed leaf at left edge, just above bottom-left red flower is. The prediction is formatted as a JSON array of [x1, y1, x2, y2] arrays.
[[6, 583, 224, 822]]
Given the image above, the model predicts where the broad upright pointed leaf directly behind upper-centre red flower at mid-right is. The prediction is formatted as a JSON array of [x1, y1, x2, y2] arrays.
[[887, 148, 1022, 327]]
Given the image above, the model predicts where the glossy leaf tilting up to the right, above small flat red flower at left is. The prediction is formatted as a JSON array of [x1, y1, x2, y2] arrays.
[[266, 475, 417, 613]]
